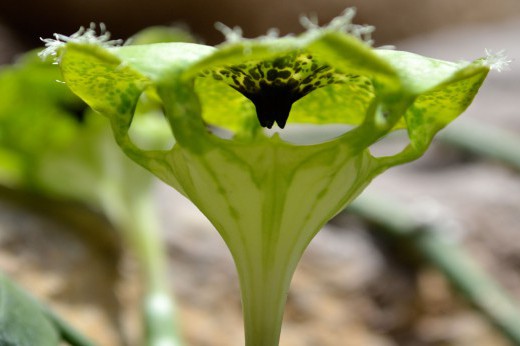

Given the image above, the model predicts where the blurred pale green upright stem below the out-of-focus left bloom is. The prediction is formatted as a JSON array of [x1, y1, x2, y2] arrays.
[[104, 189, 182, 346]]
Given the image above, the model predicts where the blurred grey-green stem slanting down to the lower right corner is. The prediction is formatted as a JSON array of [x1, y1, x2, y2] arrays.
[[347, 195, 520, 345]]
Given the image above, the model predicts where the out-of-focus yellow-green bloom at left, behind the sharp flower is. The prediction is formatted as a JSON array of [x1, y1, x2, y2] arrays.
[[0, 53, 160, 218]]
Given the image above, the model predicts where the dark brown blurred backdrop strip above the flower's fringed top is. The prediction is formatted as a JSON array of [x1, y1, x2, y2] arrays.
[[0, 0, 520, 61]]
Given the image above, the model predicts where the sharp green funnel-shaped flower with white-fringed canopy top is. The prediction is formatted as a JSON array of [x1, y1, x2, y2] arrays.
[[45, 10, 498, 345]]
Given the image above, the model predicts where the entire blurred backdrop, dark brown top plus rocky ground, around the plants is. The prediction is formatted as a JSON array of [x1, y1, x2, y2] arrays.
[[0, 0, 520, 346]]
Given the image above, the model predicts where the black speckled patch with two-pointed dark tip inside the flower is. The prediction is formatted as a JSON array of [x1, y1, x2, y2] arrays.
[[203, 53, 358, 128]]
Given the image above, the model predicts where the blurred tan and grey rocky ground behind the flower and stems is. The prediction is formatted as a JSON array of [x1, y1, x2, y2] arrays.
[[0, 7, 520, 346]]
